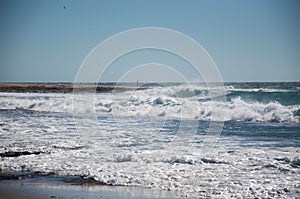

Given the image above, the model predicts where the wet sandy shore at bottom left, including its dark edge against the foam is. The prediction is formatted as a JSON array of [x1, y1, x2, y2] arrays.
[[0, 172, 182, 199]]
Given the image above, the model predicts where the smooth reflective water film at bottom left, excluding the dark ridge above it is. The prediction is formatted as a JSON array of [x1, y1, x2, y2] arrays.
[[0, 176, 183, 199]]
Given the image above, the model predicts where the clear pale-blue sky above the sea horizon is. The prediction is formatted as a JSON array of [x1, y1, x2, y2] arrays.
[[0, 0, 300, 82]]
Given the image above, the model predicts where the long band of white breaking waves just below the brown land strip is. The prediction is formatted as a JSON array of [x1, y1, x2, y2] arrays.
[[0, 86, 300, 123]]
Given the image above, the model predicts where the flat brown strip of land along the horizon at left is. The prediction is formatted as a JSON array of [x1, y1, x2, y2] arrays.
[[0, 83, 146, 93]]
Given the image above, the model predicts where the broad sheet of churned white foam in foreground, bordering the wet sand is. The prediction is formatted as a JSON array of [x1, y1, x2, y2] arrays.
[[0, 114, 300, 198]]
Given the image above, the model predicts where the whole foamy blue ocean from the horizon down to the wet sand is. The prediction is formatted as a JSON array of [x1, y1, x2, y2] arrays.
[[0, 82, 300, 198]]
